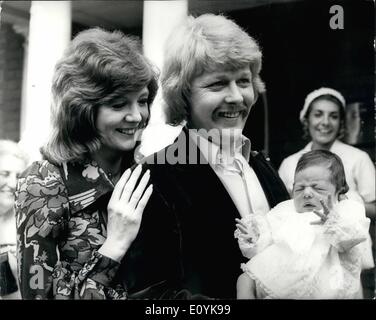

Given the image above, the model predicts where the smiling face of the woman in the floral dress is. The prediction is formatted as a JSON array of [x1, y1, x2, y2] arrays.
[[96, 87, 149, 153]]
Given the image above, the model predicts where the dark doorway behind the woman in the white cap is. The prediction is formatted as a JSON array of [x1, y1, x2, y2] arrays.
[[227, 0, 375, 167]]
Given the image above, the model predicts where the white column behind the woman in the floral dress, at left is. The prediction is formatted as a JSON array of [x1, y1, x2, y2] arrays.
[[20, 1, 71, 159]]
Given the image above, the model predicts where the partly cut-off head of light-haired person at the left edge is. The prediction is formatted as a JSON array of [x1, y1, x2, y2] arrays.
[[0, 155, 25, 216]]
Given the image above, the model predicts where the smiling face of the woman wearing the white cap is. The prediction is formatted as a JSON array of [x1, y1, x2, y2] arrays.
[[307, 99, 341, 148]]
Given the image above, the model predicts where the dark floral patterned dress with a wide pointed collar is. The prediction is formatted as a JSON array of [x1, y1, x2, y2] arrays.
[[15, 160, 126, 299]]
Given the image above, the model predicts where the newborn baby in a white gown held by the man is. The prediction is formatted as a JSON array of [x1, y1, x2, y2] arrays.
[[235, 150, 373, 299]]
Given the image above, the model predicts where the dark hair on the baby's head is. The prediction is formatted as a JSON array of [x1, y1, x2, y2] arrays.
[[295, 150, 349, 196]]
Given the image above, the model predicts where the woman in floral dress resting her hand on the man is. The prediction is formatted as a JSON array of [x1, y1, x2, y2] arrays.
[[16, 28, 157, 299]]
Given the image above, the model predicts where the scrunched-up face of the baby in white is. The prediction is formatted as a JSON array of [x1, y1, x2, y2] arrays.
[[293, 166, 337, 212]]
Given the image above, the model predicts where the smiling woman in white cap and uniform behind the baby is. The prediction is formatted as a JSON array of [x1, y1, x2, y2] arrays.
[[278, 88, 376, 219]]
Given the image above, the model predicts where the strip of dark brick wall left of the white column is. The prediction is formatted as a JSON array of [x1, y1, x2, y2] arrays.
[[0, 23, 24, 141]]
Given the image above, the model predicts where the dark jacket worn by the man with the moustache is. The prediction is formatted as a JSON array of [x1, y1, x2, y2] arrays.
[[121, 130, 289, 299]]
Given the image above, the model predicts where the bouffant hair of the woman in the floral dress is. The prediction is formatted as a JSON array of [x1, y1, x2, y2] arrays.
[[43, 28, 158, 163]]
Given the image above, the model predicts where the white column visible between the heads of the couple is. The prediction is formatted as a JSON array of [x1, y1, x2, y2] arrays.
[[141, 0, 188, 155]]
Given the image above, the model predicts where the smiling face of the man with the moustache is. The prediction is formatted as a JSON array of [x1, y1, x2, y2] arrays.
[[188, 67, 256, 136]]
